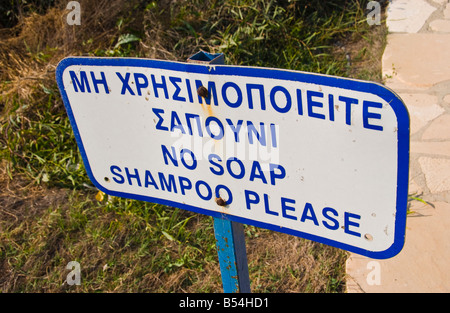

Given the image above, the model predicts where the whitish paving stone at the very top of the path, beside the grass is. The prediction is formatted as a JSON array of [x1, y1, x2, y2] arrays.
[[386, 0, 436, 33]]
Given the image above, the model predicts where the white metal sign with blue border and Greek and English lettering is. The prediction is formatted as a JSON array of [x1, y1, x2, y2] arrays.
[[56, 58, 409, 258]]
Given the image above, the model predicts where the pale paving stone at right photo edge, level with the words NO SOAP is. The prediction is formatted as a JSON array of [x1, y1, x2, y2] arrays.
[[418, 157, 450, 193]]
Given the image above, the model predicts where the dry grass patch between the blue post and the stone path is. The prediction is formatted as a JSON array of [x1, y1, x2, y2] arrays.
[[247, 231, 348, 293]]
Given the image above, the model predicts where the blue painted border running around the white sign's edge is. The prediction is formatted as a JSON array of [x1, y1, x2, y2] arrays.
[[56, 57, 410, 259]]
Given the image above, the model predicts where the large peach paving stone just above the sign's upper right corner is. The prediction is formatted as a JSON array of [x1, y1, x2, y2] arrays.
[[382, 33, 450, 90]]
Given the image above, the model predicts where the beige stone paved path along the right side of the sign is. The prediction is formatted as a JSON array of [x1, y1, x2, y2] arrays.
[[347, 0, 450, 292]]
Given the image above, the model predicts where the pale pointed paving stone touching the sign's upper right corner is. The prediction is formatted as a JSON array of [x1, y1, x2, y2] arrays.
[[399, 93, 444, 135]]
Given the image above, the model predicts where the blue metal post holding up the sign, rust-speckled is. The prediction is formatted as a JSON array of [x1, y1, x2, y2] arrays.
[[187, 51, 250, 293]]
